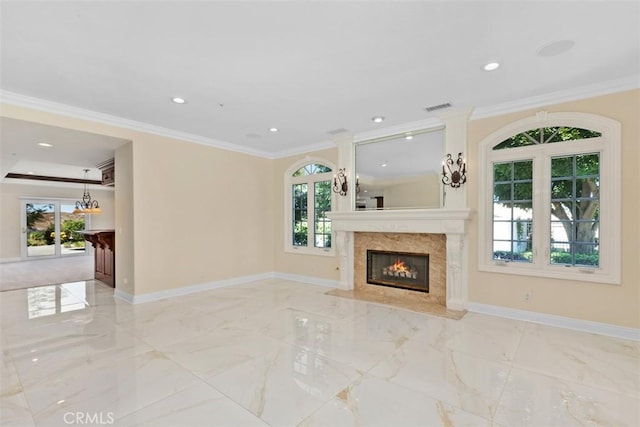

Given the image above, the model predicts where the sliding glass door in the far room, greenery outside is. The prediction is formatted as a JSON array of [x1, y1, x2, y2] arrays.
[[21, 200, 88, 258]]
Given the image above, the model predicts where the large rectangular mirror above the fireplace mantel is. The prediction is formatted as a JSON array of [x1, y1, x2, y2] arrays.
[[354, 126, 445, 210]]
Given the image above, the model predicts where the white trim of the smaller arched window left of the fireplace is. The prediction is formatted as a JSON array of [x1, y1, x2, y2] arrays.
[[283, 156, 338, 256]]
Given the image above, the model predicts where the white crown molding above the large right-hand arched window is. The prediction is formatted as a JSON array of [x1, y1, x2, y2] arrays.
[[470, 75, 640, 120]]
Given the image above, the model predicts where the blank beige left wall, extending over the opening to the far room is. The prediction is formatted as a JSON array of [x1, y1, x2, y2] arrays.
[[2, 105, 275, 295]]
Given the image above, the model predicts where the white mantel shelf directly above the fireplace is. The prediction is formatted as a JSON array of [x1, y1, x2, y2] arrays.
[[327, 209, 471, 234]]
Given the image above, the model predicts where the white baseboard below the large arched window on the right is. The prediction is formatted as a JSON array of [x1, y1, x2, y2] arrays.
[[467, 303, 640, 341]]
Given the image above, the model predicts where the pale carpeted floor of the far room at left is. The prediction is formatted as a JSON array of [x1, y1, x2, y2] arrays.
[[0, 256, 93, 291]]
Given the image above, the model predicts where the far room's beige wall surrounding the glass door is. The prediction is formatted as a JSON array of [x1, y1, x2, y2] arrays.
[[0, 181, 114, 261]]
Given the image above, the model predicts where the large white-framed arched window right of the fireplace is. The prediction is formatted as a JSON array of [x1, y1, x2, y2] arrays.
[[479, 113, 621, 283]]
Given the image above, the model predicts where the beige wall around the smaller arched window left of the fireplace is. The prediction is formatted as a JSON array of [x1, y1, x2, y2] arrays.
[[271, 148, 342, 281]]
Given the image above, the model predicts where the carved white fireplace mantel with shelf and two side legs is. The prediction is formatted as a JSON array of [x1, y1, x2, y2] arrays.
[[328, 209, 471, 311]]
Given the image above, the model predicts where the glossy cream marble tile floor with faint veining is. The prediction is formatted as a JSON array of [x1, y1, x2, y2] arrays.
[[0, 279, 640, 427]]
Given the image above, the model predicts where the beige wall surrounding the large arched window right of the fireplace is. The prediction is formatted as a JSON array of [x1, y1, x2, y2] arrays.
[[467, 90, 640, 328]]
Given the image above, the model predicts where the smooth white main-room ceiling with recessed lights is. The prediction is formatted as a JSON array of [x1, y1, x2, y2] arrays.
[[0, 0, 640, 181]]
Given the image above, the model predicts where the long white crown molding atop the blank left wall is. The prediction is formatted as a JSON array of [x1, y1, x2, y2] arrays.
[[0, 90, 273, 158]]
